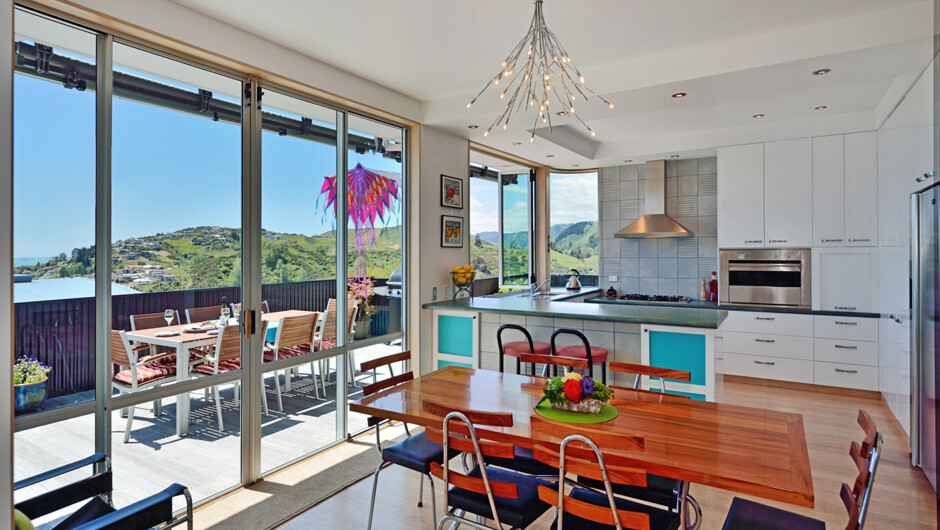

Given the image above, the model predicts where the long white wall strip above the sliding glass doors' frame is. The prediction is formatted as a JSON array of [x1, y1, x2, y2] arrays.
[[60, 0, 422, 121]]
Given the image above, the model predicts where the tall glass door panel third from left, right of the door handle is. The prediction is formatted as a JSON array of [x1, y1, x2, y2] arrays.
[[261, 89, 338, 472]]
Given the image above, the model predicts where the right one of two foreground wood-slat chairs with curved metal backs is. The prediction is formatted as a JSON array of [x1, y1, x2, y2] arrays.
[[535, 433, 679, 530]]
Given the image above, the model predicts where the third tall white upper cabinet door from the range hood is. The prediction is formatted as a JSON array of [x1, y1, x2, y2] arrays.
[[813, 134, 844, 247]]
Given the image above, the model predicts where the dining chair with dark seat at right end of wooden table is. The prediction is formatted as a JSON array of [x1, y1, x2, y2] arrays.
[[722, 410, 884, 530]]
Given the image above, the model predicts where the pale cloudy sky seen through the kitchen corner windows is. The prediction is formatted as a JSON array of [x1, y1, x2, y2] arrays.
[[470, 172, 598, 235]]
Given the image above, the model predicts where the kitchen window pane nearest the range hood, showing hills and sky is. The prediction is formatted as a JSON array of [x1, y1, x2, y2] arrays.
[[548, 171, 600, 287]]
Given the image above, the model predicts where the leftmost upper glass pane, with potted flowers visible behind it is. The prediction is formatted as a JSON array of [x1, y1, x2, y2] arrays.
[[13, 10, 96, 416]]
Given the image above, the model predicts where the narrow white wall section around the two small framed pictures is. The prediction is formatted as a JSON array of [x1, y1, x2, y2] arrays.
[[412, 126, 470, 373]]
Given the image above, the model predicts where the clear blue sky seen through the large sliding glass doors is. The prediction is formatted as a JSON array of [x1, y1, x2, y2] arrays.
[[14, 62, 401, 257]]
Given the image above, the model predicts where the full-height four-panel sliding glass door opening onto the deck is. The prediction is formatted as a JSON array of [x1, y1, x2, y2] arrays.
[[13, 2, 407, 506]]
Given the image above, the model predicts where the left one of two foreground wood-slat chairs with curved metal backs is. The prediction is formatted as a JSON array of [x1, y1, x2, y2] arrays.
[[424, 402, 549, 529]]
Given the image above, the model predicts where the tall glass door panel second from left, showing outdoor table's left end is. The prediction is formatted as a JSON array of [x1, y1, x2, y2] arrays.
[[108, 43, 244, 504]]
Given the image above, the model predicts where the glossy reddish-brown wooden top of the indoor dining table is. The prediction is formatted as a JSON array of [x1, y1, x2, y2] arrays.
[[349, 365, 814, 524]]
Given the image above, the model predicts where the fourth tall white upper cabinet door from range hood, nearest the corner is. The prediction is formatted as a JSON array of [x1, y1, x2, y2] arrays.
[[845, 132, 878, 247]]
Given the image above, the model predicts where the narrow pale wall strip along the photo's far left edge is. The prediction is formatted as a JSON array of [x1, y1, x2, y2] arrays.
[[0, 1, 13, 528]]
